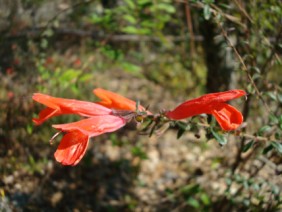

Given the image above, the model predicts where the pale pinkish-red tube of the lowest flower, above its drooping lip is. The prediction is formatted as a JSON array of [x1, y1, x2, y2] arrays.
[[52, 115, 126, 137]]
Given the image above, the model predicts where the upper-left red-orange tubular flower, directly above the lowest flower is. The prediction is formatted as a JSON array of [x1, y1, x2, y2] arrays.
[[32, 93, 112, 125]]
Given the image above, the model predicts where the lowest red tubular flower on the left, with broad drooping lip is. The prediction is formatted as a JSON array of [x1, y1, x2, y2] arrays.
[[53, 115, 126, 166]]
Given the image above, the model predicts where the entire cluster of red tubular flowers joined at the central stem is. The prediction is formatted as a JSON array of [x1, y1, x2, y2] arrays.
[[33, 88, 246, 165]]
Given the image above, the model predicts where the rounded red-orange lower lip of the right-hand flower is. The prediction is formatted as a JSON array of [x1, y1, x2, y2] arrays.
[[211, 103, 243, 131]]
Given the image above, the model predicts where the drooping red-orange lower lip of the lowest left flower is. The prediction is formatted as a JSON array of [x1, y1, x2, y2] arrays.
[[54, 131, 89, 166]]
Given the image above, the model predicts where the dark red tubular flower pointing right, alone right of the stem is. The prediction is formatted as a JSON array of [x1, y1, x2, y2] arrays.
[[165, 90, 246, 130]]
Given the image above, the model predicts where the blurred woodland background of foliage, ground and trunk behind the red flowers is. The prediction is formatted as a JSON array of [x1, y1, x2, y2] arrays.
[[0, 0, 282, 211]]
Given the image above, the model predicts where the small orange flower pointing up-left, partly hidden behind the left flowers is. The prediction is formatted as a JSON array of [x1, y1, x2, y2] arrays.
[[93, 88, 146, 111]]
